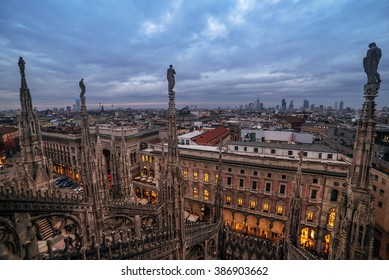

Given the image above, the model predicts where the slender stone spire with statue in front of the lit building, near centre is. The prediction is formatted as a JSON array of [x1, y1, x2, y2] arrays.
[[161, 65, 185, 259]]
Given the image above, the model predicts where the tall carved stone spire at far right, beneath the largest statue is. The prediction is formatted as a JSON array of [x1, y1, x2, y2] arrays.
[[329, 43, 381, 260]]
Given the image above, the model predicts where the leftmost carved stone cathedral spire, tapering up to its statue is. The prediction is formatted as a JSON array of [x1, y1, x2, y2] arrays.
[[18, 57, 52, 190]]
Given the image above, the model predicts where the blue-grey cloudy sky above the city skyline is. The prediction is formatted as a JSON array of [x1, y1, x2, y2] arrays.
[[0, 0, 389, 109]]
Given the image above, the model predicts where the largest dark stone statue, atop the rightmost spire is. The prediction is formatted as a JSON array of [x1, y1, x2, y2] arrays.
[[363, 42, 382, 84]]
